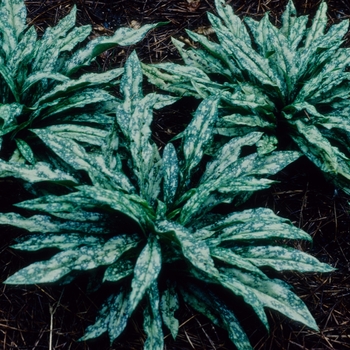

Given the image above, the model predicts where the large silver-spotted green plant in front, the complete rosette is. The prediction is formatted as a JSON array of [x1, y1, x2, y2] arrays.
[[0, 53, 332, 350]]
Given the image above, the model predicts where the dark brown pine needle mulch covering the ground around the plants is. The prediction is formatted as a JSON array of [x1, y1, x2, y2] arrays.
[[0, 0, 350, 350]]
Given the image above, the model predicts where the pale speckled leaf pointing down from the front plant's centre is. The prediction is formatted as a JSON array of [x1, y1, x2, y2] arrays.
[[129, 235, 162, 315]]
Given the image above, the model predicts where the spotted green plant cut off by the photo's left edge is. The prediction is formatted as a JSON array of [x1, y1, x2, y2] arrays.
[[0, 0, 163, 182]]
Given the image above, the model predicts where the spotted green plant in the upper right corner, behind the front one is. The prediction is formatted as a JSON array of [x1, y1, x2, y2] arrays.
[[143, 0, 350, 193]]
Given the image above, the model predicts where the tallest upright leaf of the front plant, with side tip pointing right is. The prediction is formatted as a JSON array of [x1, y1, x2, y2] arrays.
[[116, 52, 176, 202]]
